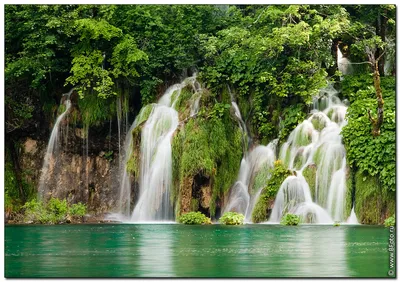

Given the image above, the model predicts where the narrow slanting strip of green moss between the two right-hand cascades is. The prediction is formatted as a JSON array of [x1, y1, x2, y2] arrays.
[[251, 160, 292, 223]]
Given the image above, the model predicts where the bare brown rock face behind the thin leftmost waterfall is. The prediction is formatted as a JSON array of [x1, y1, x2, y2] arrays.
[[19, 125, 119, 215]]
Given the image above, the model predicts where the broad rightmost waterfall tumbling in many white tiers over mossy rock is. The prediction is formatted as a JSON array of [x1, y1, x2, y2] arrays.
[[269, 85, 347, 223]]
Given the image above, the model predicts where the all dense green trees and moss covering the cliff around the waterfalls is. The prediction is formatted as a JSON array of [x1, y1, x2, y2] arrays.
[[5, 5, 396, 223]]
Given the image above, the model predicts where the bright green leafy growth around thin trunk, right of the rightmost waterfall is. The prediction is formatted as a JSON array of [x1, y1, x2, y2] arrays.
[[342, 76, 396, 191]]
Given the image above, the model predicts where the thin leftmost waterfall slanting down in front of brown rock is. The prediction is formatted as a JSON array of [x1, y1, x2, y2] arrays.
[[38, 88, 74, 200]]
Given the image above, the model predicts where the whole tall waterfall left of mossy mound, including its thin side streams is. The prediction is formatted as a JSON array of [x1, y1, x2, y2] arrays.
[[116, 75, 201, 222]]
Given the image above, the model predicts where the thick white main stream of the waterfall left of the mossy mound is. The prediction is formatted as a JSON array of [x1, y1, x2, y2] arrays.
[[131, 75, 202, 222]]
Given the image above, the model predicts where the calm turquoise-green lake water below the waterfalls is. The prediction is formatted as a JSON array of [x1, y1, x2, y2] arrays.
[[5, 224, 395, 277]]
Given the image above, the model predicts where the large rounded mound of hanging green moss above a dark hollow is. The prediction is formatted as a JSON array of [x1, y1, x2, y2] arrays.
[[172, 109, 242, 215]]
